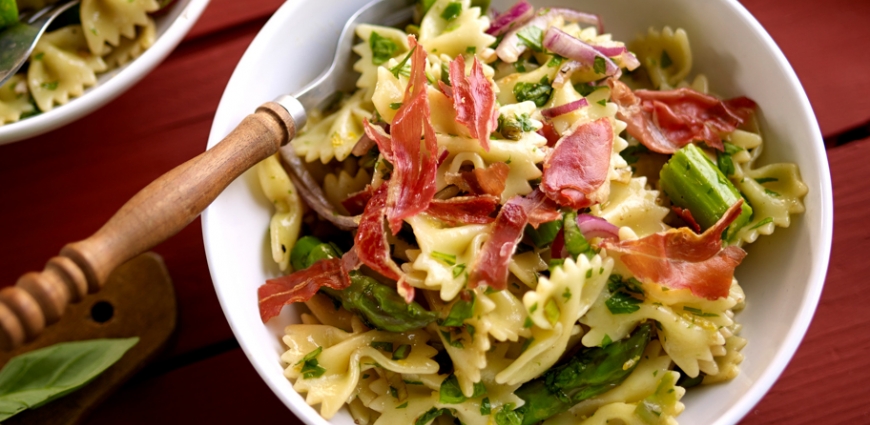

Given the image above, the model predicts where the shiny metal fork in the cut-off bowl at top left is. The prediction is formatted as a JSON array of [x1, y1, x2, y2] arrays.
[[0, 0, 79, 86]]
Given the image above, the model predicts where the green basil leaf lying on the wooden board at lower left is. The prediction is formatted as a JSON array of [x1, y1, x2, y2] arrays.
[[0, 337, 139, 421]]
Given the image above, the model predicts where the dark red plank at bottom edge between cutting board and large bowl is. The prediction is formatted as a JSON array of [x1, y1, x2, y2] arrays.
[[85, 349, 302, 425]]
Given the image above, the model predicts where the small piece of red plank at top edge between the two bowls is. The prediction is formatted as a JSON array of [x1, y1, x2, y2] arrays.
[[186, 0, 284, 39]]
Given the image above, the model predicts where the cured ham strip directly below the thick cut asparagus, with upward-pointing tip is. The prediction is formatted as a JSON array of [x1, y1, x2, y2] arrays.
[[602, 199, 746, 300]]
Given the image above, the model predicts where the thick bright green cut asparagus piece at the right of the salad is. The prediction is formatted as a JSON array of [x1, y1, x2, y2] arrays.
[[659, 144, 752, 242]]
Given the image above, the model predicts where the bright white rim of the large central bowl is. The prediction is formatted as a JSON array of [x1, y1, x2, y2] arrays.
[[202, 0, 833, 425]]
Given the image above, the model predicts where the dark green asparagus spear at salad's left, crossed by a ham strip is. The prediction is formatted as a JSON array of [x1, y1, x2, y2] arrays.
[[290, 236, 437, 332]]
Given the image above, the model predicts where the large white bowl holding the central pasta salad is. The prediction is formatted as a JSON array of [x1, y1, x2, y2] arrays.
[[203, 0, 833, 424]]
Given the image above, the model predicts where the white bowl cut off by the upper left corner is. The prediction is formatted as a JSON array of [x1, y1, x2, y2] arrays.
[[0, 0, 209, 145]]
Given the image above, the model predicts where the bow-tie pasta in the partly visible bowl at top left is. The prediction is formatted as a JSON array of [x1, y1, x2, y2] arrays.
[[0, 0, 172, 125]]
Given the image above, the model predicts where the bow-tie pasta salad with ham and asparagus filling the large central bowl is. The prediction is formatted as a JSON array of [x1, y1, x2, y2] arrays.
[[257, 0, 807, 425]]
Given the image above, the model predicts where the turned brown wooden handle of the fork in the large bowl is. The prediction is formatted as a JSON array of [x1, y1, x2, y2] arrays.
[[0, 102, 296, 350]]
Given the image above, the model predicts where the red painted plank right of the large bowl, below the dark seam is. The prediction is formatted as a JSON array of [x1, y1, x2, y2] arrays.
[[743, 139, 870, 425]]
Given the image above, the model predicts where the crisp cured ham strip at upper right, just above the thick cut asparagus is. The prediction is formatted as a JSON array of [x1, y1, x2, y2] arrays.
[[608, 79, 756, 154]]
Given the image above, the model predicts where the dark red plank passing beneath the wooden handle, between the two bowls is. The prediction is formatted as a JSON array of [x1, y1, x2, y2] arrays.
[[0, 23, 261, 355]]
